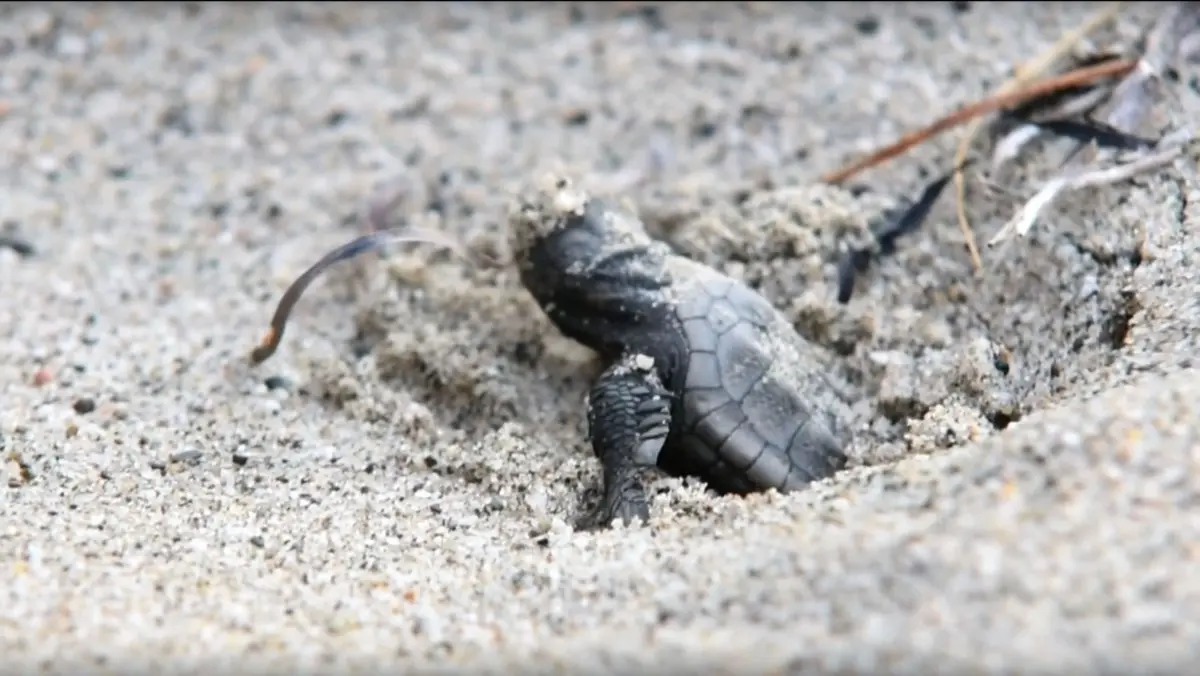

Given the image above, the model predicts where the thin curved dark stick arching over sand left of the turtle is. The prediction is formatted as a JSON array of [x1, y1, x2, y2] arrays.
[[250, 228, 474, 365]]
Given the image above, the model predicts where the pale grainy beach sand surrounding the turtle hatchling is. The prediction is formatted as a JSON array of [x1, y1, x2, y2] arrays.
[[0, 2, 1200, 674]]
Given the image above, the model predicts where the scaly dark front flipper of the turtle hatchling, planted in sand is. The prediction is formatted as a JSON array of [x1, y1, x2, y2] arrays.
[[577, 354, 671, 530]]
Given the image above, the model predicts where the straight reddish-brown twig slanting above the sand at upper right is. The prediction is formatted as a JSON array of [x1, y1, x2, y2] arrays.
[[821, 59, 1138, 184]]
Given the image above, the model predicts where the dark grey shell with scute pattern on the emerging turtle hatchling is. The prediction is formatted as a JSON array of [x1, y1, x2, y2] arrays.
[[670, 258, 850, 492]]
